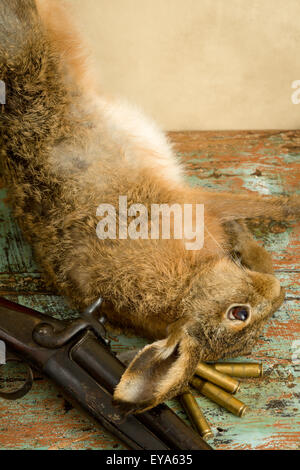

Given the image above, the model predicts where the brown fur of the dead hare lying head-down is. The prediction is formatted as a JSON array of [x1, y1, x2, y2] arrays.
[[0, 0, 300, 411]]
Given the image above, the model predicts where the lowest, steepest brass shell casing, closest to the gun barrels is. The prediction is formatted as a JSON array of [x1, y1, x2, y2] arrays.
[[180, 391, 213, 439]]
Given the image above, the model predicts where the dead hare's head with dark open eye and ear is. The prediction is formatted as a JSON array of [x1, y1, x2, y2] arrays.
[[114, 258, 284, 413]]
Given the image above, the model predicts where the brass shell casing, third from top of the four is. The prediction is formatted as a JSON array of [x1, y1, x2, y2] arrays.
[[191, 377, 248, 417]]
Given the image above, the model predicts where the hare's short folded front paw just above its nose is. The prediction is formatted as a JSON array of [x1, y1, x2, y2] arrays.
[[224, 220, 274, 274]]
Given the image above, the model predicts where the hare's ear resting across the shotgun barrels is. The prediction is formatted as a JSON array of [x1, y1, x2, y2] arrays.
[[113, 322, 200, 414]]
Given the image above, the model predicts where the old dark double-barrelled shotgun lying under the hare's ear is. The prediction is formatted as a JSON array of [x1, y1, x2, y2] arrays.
[[0, 297, 212, 450]]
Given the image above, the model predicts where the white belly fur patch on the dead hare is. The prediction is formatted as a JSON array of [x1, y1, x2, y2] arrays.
[[50, 94, 182, 183]]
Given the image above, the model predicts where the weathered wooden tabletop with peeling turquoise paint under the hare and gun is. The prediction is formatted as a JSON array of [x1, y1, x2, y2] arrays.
[[0, 131, 300, 449]]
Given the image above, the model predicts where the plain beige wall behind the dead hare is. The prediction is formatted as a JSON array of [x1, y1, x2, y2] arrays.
[[68, 0, 300, 130]]
